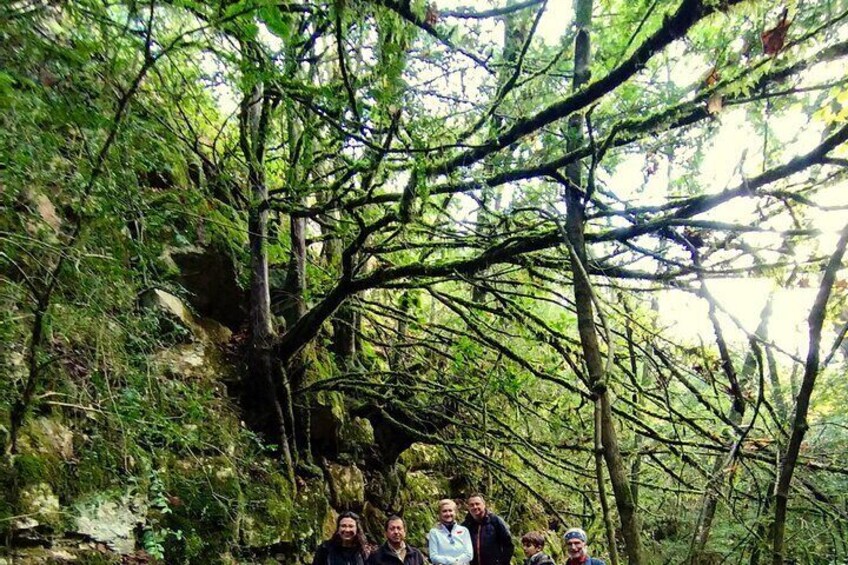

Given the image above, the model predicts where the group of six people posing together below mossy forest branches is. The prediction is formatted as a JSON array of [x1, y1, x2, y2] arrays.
[[312, 494, 604, 565]]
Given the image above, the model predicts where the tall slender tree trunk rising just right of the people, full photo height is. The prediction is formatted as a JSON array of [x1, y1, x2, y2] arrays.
[[565, 0, 642, 565]]
